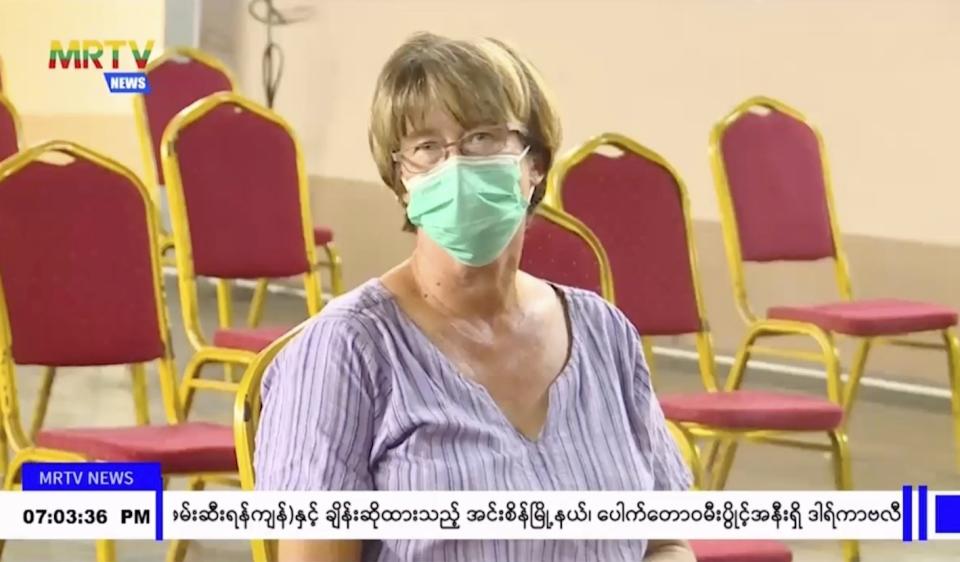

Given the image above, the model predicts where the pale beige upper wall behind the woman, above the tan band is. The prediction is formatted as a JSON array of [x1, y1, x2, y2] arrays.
[[239, 0, 960, 244]]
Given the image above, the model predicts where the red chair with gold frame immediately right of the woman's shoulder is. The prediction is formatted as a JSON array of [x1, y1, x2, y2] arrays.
[[545, 133, 859, 562]]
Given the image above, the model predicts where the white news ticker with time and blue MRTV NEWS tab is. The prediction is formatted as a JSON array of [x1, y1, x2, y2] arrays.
[[0, 463, 960, 542]]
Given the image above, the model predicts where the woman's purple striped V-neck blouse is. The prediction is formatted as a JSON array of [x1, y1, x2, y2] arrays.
[[255, 280, 690, 562]]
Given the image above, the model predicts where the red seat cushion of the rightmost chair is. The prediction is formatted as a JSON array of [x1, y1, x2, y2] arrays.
[[767, 299, 957, 336]]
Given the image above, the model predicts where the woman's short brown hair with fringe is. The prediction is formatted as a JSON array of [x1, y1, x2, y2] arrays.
[[369, 33, 561, 230]]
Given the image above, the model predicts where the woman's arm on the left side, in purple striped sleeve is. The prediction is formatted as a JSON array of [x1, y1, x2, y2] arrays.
[[254, 314, 376, 562]]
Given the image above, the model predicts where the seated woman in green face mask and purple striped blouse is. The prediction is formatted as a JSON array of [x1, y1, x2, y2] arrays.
[[256, 34, 693, 562]]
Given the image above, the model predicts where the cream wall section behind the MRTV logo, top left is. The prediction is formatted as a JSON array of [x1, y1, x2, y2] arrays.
[[0, 0, 164, 172]]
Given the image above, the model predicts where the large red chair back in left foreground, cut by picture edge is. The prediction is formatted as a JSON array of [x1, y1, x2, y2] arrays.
[[0, 141, 166, 366]]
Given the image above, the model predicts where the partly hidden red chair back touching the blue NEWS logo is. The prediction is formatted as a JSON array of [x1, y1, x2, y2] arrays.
[[140, 47, 234, 185]]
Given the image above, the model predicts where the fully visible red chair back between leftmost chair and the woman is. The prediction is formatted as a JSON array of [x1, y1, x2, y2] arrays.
[[162, 93, 313, 278]]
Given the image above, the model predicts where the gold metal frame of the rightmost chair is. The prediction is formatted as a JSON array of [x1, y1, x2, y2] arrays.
[[709, 96, 960, 466]]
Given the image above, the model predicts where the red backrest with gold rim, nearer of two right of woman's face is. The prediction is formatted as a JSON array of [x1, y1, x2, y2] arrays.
[[548, 133, 703, 336]]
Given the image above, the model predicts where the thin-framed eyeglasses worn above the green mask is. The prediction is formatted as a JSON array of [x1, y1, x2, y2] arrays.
[[393, 126, 526, 173]]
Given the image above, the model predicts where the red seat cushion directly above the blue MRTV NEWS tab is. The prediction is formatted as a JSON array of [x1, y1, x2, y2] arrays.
[[37, 422, 237, 474]]
